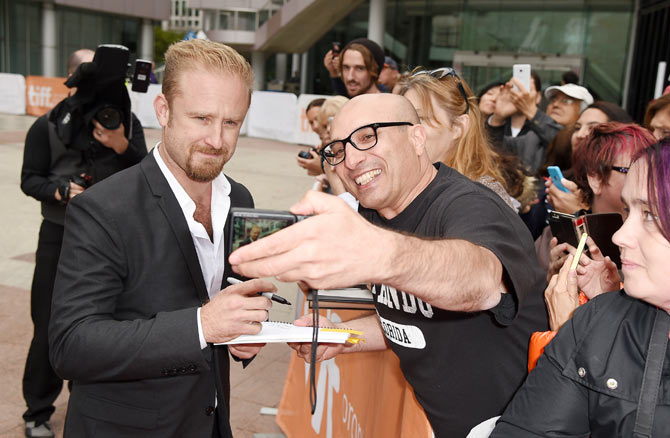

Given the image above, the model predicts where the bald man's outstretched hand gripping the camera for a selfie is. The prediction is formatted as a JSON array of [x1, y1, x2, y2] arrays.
[[229, 190, 384, 289]]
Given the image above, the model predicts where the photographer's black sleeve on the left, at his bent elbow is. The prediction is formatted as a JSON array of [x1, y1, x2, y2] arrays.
[[21, 116, 58, 203]]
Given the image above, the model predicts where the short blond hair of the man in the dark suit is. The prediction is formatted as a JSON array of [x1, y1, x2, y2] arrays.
[[163, 39, 254, 104]]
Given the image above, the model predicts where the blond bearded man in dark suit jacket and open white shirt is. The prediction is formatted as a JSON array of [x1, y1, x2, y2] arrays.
[[49, 40, 274, 438]]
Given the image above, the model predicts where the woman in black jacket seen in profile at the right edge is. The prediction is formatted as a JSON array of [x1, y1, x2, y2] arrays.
[[491, 140, 670, 438]]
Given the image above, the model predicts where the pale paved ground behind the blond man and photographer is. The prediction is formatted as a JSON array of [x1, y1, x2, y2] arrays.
[[0, 114, 312, 438]]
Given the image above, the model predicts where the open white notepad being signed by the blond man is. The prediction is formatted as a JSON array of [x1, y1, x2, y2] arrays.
[[219, 321, 352, 345]]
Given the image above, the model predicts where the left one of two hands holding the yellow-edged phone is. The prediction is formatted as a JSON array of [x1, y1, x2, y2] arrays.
[[544, 254, 579, 331]]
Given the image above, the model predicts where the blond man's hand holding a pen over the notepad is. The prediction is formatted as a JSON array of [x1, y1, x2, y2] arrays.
[[200, 279, 277, 346]]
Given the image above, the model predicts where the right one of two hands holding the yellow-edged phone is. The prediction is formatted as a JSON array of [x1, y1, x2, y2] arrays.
[[577, 237, 621, 299]]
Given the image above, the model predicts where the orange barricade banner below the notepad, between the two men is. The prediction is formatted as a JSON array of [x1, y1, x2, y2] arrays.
[[277, 310, 432, 438]]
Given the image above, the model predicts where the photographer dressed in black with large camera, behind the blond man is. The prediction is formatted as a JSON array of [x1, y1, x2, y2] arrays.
[[21, 49, 147, 437]]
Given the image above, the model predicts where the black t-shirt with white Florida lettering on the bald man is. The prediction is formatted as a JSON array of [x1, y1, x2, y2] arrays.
[[359, 164, 548, 437]]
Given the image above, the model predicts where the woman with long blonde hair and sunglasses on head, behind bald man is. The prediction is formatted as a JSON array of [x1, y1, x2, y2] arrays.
[[397, 68, 534, 211]]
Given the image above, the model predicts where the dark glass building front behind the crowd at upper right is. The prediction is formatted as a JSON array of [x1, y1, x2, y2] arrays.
[[310, 0, 634, 102]]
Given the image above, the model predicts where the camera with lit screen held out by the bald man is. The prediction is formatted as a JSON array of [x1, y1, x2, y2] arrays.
[[228, 207, 308, 252]]
